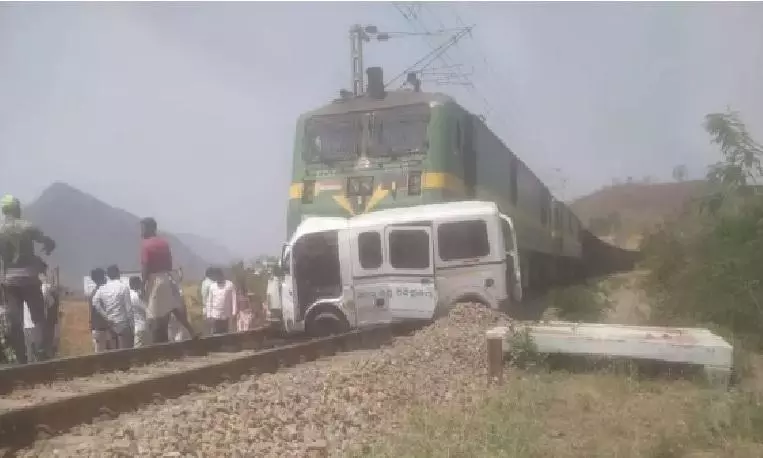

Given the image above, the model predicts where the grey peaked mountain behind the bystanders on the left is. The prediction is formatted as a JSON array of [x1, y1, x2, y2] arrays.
[[23, 183, 208, 291]]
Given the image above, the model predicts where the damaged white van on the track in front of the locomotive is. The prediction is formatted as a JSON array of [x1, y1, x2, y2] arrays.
[[267, 201, 522, 335]]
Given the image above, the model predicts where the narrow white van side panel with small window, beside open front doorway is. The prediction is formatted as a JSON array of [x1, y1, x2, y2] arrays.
[[348, 228, 392, 327]]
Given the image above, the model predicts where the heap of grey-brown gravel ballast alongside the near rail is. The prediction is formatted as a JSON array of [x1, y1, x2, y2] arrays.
[[19, 304, 507, 457]]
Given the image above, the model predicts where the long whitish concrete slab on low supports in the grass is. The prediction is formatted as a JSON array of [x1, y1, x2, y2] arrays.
[[486, 321, 734, 388]]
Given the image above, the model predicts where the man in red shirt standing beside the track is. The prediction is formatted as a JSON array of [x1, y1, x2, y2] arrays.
[[140, 218, 196, 343]]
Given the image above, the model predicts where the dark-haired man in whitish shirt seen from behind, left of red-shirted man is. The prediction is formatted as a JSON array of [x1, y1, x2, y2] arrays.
[[93, 265, 133, 349]]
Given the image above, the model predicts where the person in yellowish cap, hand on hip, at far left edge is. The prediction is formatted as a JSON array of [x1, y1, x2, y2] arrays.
[[0, 195, 56, 364]]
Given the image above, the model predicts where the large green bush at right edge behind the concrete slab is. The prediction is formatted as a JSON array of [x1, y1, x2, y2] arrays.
[[642, 112, 763, 348]]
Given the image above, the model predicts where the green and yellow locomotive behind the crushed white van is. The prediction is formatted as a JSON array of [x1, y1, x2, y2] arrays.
[[287, 68, 632, 289]]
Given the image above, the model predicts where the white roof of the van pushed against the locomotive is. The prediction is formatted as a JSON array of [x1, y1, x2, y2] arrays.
[[290, 200, 498, 244]]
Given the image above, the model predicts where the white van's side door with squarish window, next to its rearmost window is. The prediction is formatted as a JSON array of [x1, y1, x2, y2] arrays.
[[384, 225, 437, 321]]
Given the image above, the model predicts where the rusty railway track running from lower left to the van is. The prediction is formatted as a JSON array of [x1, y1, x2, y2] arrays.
[[0, 325, 414, 451]]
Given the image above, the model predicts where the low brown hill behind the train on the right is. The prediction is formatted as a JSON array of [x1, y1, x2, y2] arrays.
[[570, 180, 705, 248]]
